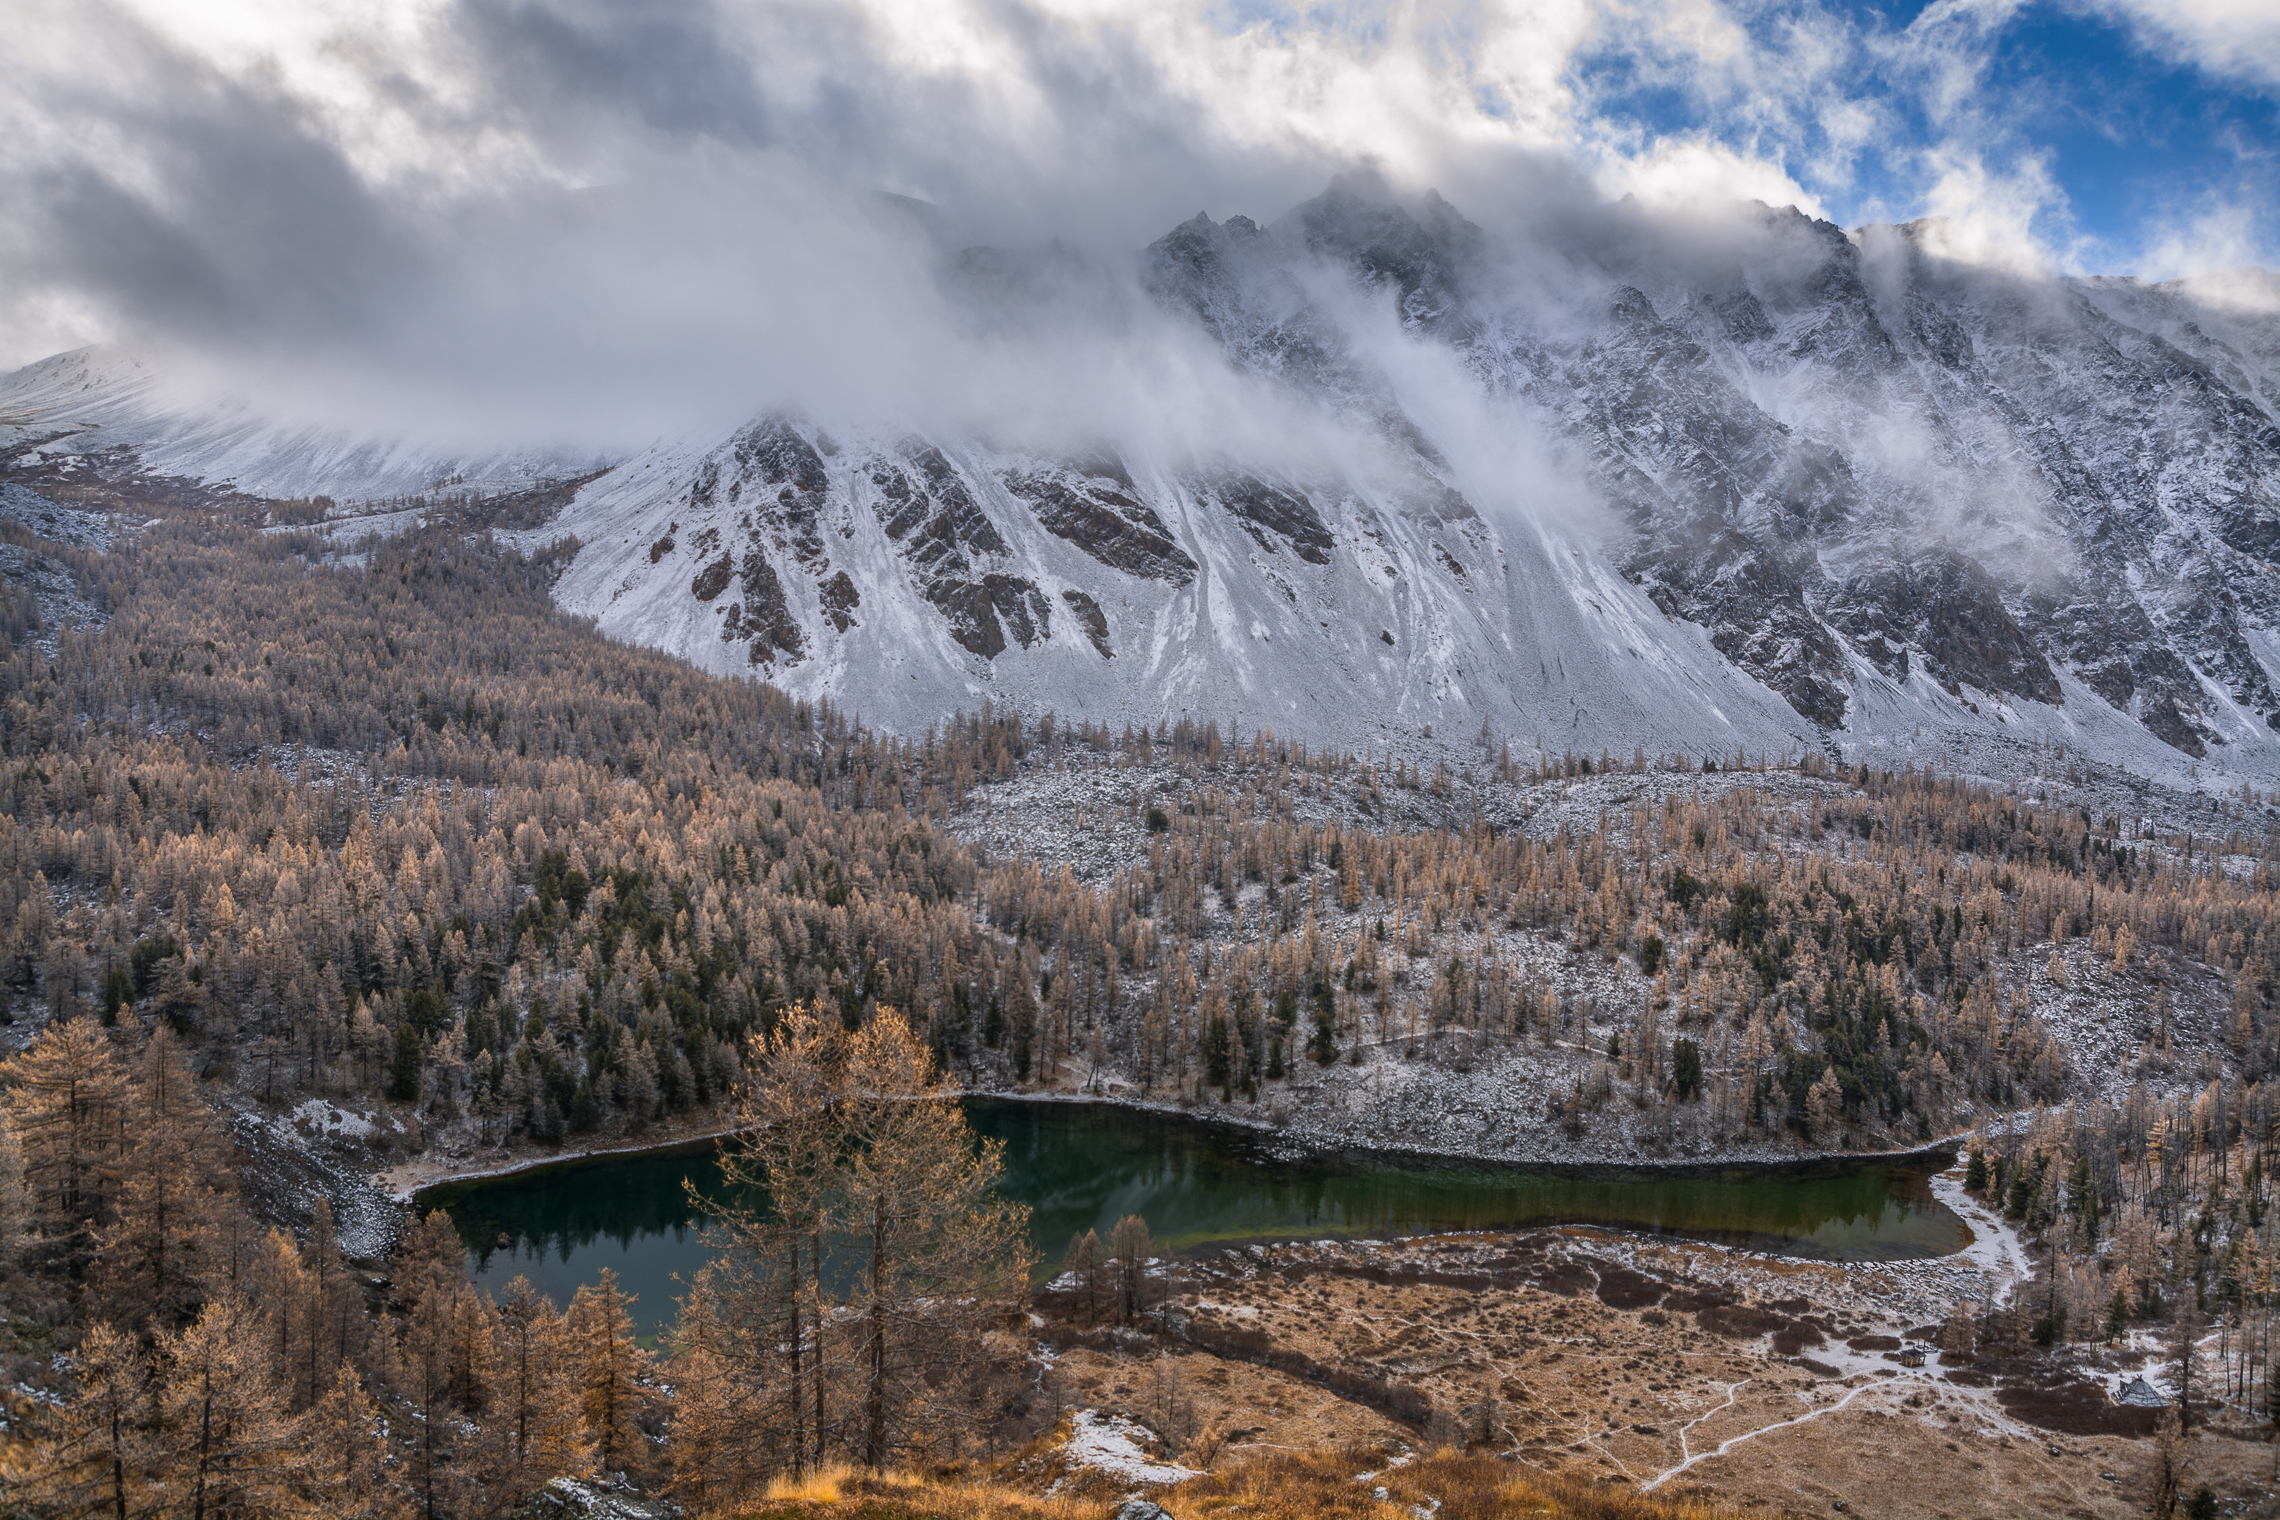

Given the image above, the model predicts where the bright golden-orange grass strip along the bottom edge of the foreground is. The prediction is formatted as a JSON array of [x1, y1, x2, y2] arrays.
[[709, 1449, 1742, 1520]]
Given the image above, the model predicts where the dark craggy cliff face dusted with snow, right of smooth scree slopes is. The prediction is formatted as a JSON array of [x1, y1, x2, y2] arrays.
[[1147, 187, 2280, 757]]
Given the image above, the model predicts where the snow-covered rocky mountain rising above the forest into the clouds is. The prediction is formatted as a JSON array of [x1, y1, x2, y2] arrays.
[[0, 182, 2280, 779]]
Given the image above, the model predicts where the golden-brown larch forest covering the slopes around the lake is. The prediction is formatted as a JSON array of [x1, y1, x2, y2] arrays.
[[0, 508, 2280, 1515]]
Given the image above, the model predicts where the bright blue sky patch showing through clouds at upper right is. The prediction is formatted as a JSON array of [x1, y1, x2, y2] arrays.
[[1571, 2, 2280, 271]]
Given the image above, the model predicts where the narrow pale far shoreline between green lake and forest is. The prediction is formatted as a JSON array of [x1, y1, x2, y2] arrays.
[[392, 1089, 1972, 1210]]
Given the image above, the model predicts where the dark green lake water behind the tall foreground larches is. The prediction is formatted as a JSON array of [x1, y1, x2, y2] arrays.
[[422, 1101, 1968, 1331]]
